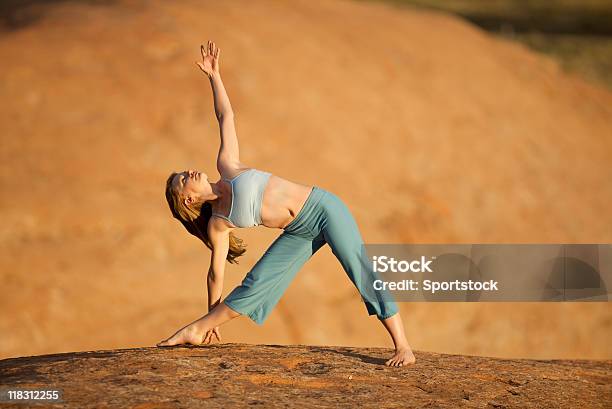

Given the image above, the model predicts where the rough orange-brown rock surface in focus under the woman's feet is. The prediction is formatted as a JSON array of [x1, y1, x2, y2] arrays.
[[0, 344, 612, 409]]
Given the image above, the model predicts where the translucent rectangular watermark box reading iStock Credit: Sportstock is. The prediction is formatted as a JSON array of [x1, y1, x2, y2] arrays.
[[360, 244, 612, 302]]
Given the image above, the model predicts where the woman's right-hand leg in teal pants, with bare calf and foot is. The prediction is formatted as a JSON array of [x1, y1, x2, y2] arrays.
[[323, 192, 415, 366]]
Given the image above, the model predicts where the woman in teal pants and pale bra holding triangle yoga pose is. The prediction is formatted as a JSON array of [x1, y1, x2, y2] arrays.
[[157, 41, 415, 366]]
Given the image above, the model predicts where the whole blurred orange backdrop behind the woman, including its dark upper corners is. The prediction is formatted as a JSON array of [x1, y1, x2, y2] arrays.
[[0, 0, 612, 359]]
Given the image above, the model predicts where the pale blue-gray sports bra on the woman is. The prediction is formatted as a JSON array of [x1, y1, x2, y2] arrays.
[[213, 169, 272, 227]]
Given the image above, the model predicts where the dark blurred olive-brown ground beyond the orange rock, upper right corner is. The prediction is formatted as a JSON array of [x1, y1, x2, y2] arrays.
[[365, 0, 612, 89]]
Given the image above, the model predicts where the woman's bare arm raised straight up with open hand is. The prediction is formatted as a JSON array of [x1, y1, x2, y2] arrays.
[[196, 41, 240, 175]]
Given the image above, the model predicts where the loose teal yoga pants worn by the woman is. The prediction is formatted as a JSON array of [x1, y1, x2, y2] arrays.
[[224, 186, 398, 325]]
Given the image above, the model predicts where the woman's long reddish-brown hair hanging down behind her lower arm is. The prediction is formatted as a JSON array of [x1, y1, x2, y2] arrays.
[[166, 172, 246, 264]]
